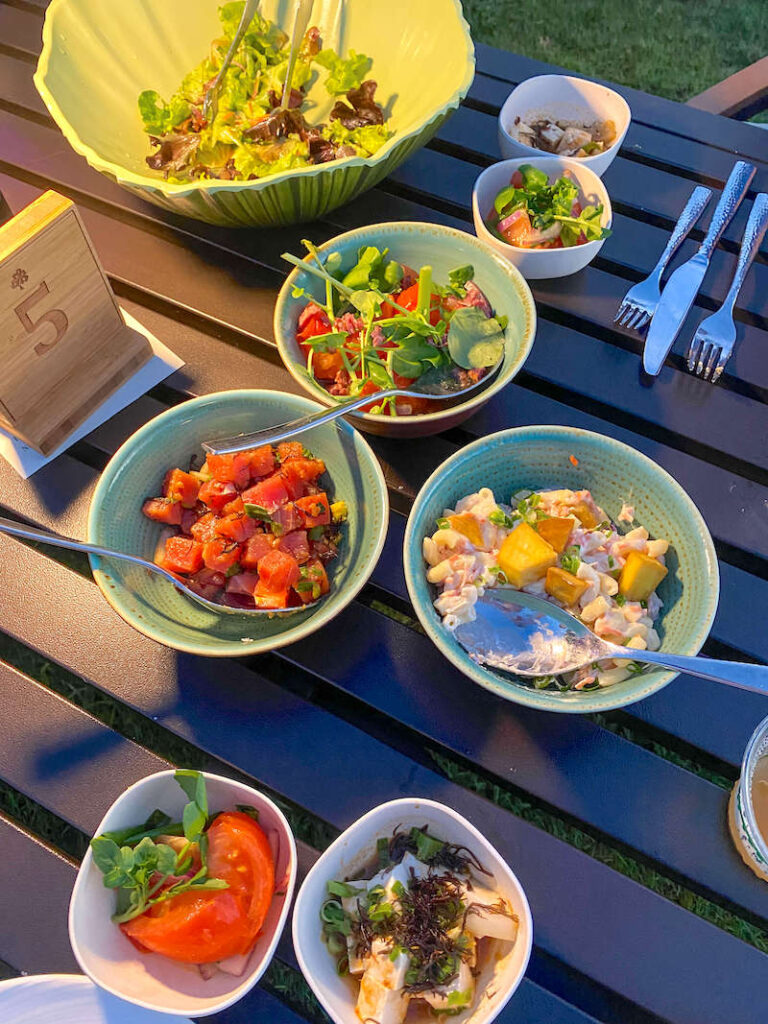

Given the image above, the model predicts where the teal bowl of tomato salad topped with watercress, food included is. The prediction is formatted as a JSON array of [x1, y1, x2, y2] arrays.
[[274, 222, 536, 437]]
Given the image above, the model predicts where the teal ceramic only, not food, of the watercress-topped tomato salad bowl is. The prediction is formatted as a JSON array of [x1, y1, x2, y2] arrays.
[[274, 221, 536, 437]]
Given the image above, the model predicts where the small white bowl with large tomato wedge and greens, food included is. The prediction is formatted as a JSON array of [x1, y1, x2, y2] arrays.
[[69, 771, 297, 1017]]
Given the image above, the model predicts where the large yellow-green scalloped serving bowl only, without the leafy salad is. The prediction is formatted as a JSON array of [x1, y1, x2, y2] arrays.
[[35, 0, 475, 227]]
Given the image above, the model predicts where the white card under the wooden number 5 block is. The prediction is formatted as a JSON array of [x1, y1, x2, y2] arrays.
[[0, 308, 184, 479]]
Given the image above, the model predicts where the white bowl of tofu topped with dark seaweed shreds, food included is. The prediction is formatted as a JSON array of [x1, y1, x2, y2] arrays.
[[293, 798, 534, 1024]]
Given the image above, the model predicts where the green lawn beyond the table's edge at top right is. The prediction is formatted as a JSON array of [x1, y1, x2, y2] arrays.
[[463, 0, 768, 100]]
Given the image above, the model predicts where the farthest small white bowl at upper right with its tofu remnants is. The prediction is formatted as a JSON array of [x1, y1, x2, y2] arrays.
[[499, 75, 632, 177]]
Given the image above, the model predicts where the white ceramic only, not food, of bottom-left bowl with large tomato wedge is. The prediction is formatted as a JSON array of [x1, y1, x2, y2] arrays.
[[70, 771, 296, 1017]]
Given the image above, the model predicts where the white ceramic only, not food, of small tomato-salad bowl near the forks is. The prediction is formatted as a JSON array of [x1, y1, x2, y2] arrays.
[[472, 151, 613, 281]]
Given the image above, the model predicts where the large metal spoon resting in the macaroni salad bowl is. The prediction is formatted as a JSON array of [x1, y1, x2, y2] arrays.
[[455, 587, 768, 693]]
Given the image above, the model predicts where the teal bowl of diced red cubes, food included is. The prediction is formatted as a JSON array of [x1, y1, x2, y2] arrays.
[[88, 390, 388, 656]]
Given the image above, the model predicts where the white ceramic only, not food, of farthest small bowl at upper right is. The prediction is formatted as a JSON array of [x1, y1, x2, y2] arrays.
[[499, 75, 632, 177]]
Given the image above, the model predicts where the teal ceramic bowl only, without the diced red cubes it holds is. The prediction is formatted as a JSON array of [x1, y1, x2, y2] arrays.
[[88, 390, 389, 656]]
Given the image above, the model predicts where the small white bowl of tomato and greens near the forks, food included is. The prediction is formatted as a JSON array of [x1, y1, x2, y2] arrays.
[[472, 157, 613, 281]]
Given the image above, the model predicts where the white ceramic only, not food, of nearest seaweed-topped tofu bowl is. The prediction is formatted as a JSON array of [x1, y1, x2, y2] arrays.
[[293, 797, 534, 1024]]
